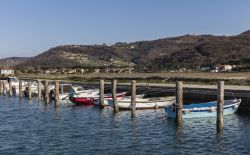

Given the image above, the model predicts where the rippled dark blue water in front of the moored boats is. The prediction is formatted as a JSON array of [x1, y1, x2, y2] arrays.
[[0, 96, 250, 155]]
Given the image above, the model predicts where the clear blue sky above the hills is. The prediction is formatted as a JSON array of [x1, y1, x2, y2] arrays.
[[0, 0, 250, 58]]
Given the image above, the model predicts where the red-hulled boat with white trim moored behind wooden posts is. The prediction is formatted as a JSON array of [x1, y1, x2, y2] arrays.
[[69, 92, 126, 106]]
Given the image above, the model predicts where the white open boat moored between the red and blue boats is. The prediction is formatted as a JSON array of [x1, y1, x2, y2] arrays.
[[106, 96, 175, 110]]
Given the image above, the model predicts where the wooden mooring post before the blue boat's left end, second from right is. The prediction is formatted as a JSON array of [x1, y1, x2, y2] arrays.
[[176, 81, 183, 126]]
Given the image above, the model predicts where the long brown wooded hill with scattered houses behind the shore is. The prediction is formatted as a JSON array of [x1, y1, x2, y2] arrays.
[[8, 31, 250, 71]]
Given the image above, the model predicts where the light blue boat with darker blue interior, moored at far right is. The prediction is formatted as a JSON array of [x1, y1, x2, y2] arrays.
[[164, 99, 241, 118]]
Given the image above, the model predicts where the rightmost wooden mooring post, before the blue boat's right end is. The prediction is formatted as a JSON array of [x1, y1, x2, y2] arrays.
[[217, 81, 224, 132]]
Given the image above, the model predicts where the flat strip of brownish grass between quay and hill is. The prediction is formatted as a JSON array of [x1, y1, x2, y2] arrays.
[[19, 72, 250, 85]]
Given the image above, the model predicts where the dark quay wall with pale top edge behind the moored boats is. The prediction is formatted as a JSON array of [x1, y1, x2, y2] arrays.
[[95, 82, 250, 113]]
